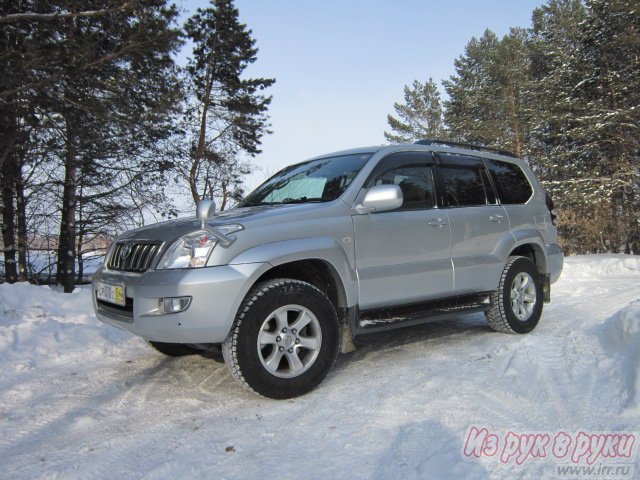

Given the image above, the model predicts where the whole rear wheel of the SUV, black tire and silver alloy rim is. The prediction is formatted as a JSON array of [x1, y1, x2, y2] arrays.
[[486, 257, 544, 333]]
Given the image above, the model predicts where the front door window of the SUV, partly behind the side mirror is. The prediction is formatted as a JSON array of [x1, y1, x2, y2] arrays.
[[373, 165, 436, 210]]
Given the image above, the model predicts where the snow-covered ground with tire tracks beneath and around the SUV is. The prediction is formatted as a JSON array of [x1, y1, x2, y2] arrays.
[[0, 255, 640, 480]]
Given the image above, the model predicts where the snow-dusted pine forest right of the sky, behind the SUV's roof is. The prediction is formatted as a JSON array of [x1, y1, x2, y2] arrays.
[[385, 0, 640, 254]]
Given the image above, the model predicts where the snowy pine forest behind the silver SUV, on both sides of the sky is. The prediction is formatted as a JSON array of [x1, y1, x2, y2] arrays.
[[0, 0, 640, 291]]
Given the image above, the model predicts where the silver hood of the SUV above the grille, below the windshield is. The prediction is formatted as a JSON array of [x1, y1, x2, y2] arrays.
[[117, 203, 336, 246]]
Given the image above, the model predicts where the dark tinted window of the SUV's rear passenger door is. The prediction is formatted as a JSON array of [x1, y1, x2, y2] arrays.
[[439, 165, 490, 207]]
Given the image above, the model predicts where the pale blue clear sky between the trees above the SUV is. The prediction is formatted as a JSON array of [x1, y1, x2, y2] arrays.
[[179, 0, 543, 190]]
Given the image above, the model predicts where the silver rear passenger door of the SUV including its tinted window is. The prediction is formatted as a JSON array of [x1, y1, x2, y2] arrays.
[[436, 153, 510, 295]]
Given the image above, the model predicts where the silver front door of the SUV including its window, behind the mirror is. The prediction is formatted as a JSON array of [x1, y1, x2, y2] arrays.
[[352, 152, 453, 310]]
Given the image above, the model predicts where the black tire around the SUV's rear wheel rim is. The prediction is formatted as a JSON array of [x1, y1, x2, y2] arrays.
[[486, 257, 544, 333]]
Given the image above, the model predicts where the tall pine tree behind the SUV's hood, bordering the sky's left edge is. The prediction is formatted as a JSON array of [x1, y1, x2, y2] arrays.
[[184, 0, 275, 207]]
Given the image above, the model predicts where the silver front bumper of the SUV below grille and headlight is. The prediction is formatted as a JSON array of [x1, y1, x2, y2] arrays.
[[92, 263, 268, 343]]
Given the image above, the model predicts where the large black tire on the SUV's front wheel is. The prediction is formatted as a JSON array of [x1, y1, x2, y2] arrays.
[[222, 278, 340, 399]]
